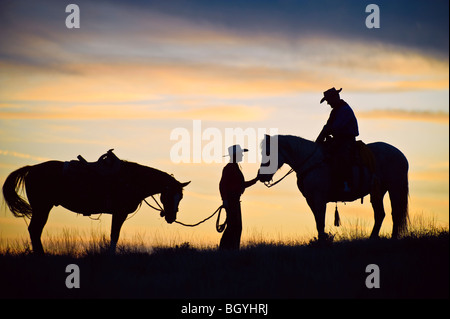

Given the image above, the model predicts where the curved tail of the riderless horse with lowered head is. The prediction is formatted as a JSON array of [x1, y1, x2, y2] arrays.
[[3, 166, 32, 218]]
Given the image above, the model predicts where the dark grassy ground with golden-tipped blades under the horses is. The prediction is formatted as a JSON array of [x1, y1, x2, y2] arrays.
[[0, 217, 449, 299]]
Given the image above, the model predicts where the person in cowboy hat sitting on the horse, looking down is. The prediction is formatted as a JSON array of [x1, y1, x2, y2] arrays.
[[316, 87, 359, 192]]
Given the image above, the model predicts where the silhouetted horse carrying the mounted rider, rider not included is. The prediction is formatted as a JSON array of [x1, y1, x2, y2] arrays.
[[259, 135, 409, 240]]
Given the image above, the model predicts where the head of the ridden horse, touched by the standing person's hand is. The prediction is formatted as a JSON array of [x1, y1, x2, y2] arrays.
[[258, 134, 284, 183]]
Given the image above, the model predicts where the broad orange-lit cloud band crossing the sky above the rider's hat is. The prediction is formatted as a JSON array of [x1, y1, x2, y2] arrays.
[[0, 34, 449, 102]]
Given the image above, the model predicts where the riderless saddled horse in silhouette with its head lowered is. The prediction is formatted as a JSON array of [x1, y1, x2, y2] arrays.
[[3, 150, 190, 254]]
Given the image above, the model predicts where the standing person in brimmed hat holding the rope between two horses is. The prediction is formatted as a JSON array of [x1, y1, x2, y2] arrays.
[[219, 145, 258, 250]]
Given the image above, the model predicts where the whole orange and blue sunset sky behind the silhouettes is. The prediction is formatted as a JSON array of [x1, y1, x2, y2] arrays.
[[0, 0, 449, 243]]
